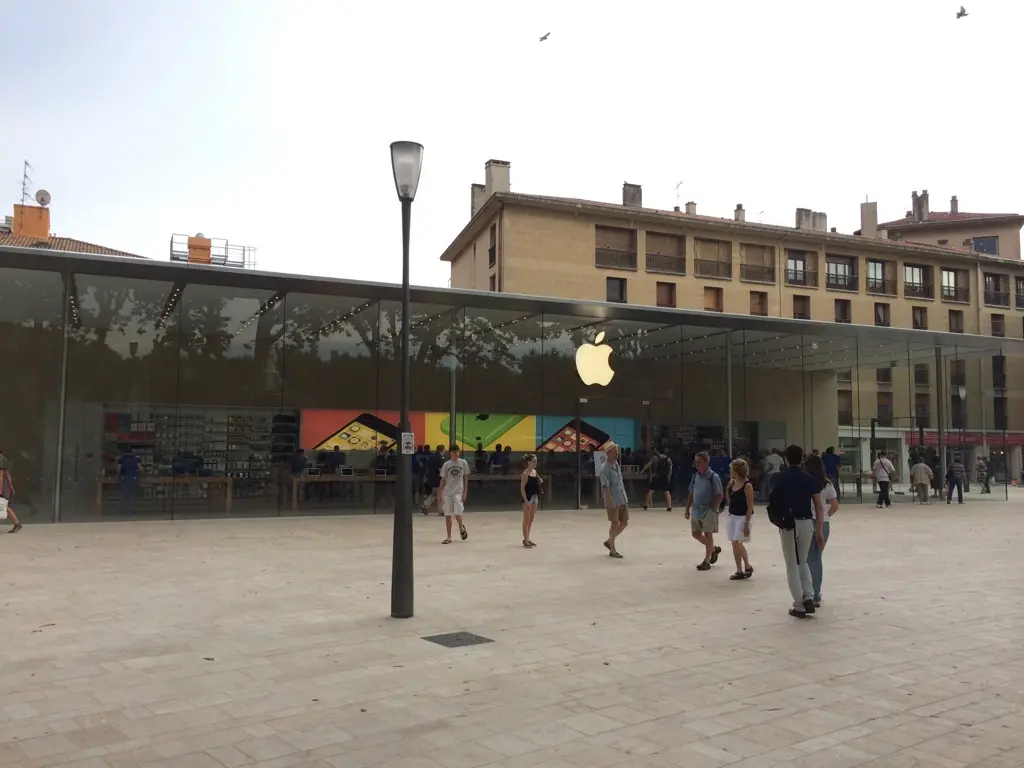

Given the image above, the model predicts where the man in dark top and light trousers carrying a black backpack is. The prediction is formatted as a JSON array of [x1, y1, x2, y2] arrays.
[[768, 445, 825, 618]]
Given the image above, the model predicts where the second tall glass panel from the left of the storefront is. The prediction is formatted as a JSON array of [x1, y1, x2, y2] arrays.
[[60, 273, 182, 520]]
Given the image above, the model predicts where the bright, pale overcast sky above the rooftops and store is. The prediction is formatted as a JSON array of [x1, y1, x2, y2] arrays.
[[0, 0, 1024, 286]]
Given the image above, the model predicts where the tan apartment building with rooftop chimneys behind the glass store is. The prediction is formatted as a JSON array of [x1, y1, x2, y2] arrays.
[[441, 160, 1024, 476]]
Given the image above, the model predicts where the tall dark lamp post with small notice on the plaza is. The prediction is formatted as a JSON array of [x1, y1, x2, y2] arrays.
[[391, 141, 423, 618]]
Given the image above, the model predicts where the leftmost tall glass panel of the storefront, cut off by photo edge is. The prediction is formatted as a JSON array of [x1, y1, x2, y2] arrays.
[[0, 268, 65, 522]]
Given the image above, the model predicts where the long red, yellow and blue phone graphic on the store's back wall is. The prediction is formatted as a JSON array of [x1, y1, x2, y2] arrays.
[[300, 410, 639, 453]]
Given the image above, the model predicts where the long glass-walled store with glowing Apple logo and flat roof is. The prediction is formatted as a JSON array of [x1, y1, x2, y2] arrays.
[[0, 248, 1024, 522]]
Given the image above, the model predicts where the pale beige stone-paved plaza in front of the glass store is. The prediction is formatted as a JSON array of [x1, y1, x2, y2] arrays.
[[0, 501, 1024, 768]]
